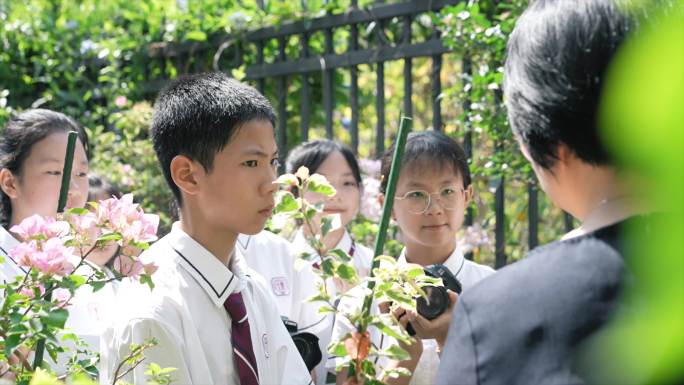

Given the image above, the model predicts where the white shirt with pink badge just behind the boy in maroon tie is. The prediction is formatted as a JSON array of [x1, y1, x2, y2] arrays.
[[237, 230, 296, 319]]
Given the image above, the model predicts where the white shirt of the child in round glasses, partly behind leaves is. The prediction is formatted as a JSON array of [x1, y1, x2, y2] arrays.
[[326, 247, 494, 385]]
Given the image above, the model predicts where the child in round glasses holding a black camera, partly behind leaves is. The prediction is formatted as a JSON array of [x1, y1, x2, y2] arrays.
[[328, 131, 494, 384]]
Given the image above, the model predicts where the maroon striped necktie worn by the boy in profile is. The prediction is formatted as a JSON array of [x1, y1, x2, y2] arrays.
[[223, 293, 259, 385]]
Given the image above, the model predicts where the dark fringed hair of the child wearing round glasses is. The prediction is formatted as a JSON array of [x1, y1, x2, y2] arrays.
[[380, 131, 470, 193]]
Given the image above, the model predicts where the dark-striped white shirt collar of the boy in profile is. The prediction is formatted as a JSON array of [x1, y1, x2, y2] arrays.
[[164, 222, 245, 307]]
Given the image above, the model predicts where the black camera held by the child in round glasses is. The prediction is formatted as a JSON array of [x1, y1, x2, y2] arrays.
[[406, 263, 462, 336]]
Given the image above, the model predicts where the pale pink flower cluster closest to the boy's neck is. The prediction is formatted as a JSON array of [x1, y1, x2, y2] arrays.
[[96, 194, 159, 245]]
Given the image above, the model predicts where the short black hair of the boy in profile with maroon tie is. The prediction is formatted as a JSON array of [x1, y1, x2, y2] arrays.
[[152, 72, 276, 206]]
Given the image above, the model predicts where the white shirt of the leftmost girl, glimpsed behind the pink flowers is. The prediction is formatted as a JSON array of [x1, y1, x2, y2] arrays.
[[0, 226, 115, 374]]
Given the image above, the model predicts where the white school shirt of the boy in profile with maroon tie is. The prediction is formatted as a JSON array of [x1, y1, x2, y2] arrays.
[[100, 223, 311, 385]]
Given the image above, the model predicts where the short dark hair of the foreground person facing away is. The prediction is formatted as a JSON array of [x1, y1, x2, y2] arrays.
[[504, 0, 634, 169]]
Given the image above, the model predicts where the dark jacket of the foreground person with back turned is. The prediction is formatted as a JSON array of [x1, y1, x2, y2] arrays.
[[435, 223, 625, 385]]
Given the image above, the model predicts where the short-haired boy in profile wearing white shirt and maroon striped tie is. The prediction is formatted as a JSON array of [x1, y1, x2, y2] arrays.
[[101, 73, 311, 385]]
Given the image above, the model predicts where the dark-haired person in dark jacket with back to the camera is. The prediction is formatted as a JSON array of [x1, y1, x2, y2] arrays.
[[436, 0, 649, 384]]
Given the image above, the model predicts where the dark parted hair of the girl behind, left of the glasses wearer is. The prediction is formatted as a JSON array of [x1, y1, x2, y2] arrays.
[[285, 139, 361, 184]]
